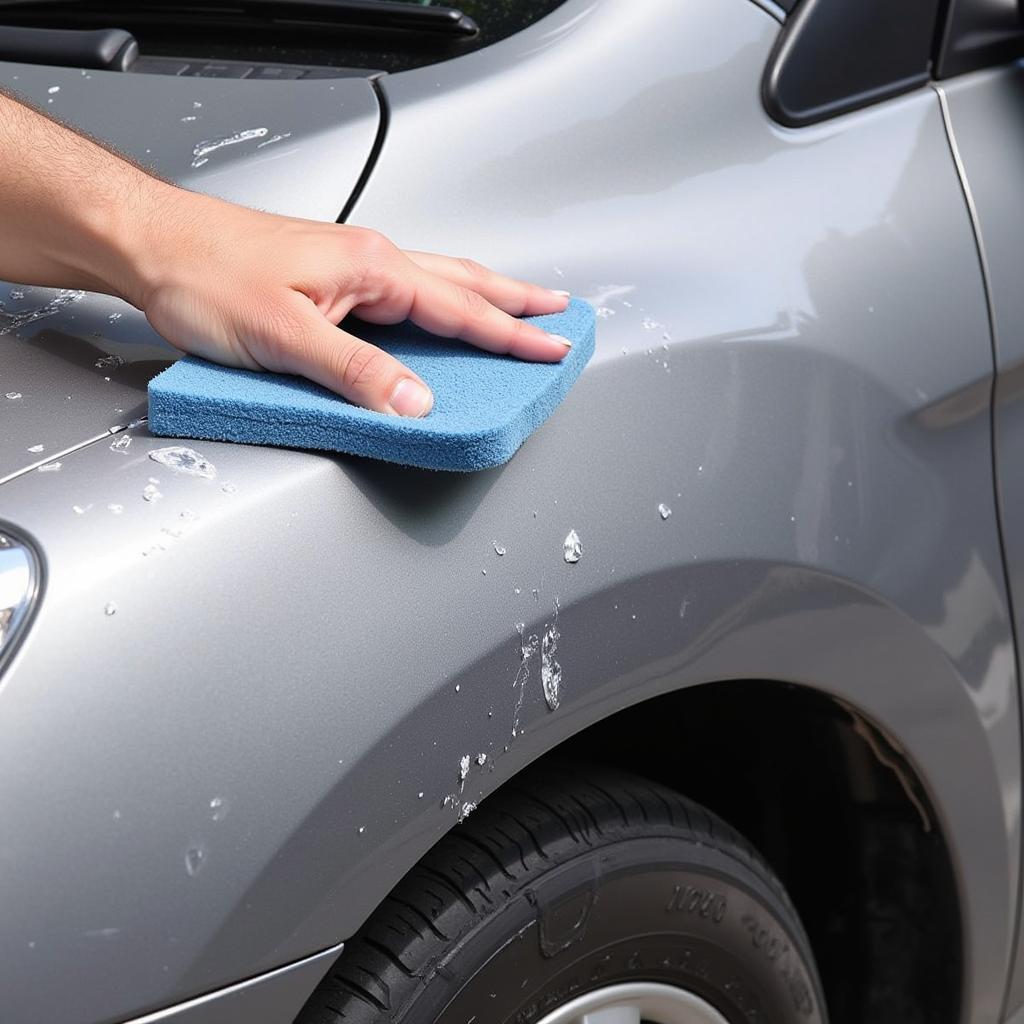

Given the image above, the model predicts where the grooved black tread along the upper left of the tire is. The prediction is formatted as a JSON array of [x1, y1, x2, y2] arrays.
[[296, 766, 796, 1024]]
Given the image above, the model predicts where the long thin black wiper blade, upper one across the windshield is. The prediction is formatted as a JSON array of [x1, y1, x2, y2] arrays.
[[0, 0, 480, 39]]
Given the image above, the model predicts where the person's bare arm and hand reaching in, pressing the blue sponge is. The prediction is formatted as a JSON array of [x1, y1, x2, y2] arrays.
[[0, 94, 567, 416]]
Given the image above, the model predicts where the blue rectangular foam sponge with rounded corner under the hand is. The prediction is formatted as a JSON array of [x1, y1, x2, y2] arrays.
[[148, 299, 596, 472]]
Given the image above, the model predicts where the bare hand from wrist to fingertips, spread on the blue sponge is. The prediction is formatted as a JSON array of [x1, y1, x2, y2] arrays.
[[124, 183, 569, 417]]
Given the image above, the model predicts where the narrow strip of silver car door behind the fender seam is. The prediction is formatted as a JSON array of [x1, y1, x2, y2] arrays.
[[941, 63, 1024, 1011]]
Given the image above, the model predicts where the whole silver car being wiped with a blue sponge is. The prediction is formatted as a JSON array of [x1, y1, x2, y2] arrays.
[[0, 0, 1024, 1024]]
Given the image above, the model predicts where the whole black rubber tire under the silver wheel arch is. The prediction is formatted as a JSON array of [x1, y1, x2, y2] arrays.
[[296, 765, 826, 1024]]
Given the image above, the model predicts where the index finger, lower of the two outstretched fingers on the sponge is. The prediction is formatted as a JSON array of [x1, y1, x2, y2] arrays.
[[409, 270, 570, 362]]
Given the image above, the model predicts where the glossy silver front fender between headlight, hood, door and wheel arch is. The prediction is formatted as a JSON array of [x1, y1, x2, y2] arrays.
[[0, 0, 1020, 1024]]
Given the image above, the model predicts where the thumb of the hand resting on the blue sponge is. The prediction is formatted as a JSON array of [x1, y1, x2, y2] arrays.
[[272, 304, 434, 418]]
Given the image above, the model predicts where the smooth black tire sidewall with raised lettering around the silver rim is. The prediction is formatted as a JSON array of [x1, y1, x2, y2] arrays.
[[415, 835, 825, 1024]]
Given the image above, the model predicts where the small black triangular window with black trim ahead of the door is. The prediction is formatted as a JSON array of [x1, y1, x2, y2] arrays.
[[761, 0, 939, 128]]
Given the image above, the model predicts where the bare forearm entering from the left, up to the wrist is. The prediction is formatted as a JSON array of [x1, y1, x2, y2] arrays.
[[0, 93, 181, 304]]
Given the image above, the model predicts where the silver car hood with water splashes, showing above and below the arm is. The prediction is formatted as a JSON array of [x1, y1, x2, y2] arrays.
[[0, 62, 380, 482]]
